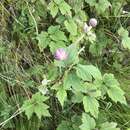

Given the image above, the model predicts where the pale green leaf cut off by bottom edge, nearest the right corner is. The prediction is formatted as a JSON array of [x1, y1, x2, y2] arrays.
[[100, 122, 120, 130]]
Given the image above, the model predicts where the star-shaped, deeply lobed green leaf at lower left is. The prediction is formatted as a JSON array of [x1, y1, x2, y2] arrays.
[[21, 93, 51, 119]]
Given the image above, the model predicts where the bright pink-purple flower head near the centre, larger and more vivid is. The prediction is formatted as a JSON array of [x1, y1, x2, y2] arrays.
[[54, 48, 68, 61]]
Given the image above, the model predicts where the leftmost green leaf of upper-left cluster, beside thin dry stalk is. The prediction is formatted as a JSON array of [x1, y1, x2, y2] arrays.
[[37, 32, 50, 51]]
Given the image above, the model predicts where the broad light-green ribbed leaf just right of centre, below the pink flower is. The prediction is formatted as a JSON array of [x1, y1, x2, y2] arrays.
[[76, 64, 102, 81]]
